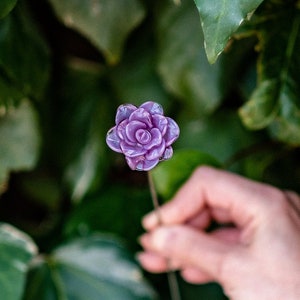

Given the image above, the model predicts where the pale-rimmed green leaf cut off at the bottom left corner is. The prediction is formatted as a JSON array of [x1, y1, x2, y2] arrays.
[[0, 223, 37, 300]]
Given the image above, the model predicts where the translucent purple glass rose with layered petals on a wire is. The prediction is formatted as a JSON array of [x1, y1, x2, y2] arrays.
[[106, 101, 179, 171]]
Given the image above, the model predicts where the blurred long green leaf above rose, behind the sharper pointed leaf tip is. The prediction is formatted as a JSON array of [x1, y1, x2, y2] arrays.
[[156, 1, 224, 115]]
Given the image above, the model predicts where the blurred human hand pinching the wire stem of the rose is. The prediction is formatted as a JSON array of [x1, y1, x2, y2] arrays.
[[139, 167, 300, 300]]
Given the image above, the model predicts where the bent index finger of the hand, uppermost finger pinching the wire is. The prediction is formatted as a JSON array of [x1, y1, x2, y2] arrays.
[[143, 166, 282, 230]]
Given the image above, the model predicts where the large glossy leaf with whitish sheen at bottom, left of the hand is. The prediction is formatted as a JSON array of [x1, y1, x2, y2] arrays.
[[24, 235, 155, 300]]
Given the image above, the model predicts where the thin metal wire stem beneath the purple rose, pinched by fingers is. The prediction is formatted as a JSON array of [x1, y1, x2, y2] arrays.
[[147, 171, 181, 300]]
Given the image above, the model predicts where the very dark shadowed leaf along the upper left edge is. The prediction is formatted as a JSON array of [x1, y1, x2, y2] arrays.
[[0, 2, 50, 99]]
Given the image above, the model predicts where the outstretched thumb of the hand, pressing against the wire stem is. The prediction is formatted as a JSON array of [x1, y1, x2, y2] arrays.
[[142, 225, 234, 282]]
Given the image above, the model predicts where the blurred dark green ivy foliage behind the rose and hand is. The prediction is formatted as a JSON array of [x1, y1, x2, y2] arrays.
[[0, 0, 300, 300]]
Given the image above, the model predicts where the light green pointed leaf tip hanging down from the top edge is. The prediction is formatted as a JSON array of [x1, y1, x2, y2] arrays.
[[194, 0, 263, 63]]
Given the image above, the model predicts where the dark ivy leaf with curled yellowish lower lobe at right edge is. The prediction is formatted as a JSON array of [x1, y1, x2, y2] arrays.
[[240, 1, 300, 145]]
